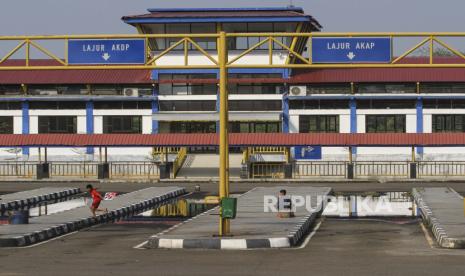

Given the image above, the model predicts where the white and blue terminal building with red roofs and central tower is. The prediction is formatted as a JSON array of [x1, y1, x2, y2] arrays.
[[0, 7, 465, 166]]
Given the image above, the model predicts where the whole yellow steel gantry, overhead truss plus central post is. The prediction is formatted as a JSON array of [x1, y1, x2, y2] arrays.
[[0, 32, 465, 236]]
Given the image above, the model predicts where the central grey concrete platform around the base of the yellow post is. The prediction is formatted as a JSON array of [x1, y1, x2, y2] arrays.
[[145, 186, 331, 249]]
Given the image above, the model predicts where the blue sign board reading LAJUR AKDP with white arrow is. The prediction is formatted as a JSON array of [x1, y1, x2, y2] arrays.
[[68, 39, 146, 64]]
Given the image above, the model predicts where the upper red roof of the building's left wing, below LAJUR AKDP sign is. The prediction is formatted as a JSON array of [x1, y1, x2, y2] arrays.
[[0, 60, 152, 84]]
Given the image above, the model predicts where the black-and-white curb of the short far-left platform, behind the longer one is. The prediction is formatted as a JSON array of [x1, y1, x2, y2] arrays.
[[0, 188, 81, 214]]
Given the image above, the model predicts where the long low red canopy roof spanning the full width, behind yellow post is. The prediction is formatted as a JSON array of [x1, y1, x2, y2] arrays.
[[0, 133, 465, 147]]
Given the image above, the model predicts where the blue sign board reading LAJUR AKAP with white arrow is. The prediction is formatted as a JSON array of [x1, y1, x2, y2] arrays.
[[312, 37, 392, 63]]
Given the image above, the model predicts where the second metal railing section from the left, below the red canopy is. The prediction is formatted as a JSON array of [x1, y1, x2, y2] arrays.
[[50, 162, 98, 178]]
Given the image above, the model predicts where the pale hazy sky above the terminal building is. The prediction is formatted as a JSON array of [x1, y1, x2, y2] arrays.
[[0, 0, 465, 35]]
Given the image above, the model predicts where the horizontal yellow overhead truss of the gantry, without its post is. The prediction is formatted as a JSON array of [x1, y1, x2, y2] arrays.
[[0, 32, 465, 70]]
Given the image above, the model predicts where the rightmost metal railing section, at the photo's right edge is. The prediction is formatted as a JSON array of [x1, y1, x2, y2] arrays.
[[417, 161, 465, 177]]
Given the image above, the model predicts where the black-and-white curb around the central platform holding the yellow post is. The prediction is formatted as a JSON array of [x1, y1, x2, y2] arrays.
[[144, 188, 323, 250]]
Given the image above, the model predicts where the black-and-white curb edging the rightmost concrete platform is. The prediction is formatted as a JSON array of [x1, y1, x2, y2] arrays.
[[412, 188, 465, 249]]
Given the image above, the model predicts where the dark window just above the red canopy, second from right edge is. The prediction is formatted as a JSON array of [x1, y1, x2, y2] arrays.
[[366, 115, 405, 133]]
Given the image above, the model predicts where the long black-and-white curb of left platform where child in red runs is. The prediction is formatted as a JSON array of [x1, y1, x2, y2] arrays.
[[0, 188, 186, 247]]
